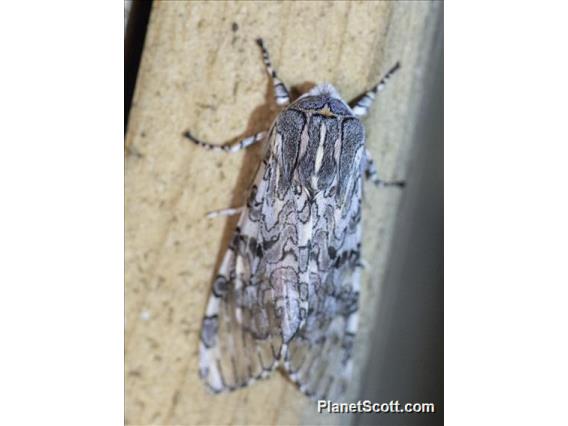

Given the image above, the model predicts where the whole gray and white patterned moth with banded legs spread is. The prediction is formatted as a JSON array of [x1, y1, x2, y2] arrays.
[[184, 39, 403, 400]]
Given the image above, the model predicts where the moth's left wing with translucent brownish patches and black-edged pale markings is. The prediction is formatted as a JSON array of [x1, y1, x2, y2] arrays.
[[199, 154, 292, 392]]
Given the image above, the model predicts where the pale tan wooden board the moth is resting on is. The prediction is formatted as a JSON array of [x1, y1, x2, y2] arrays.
[[125, 1, 441, 425]]
